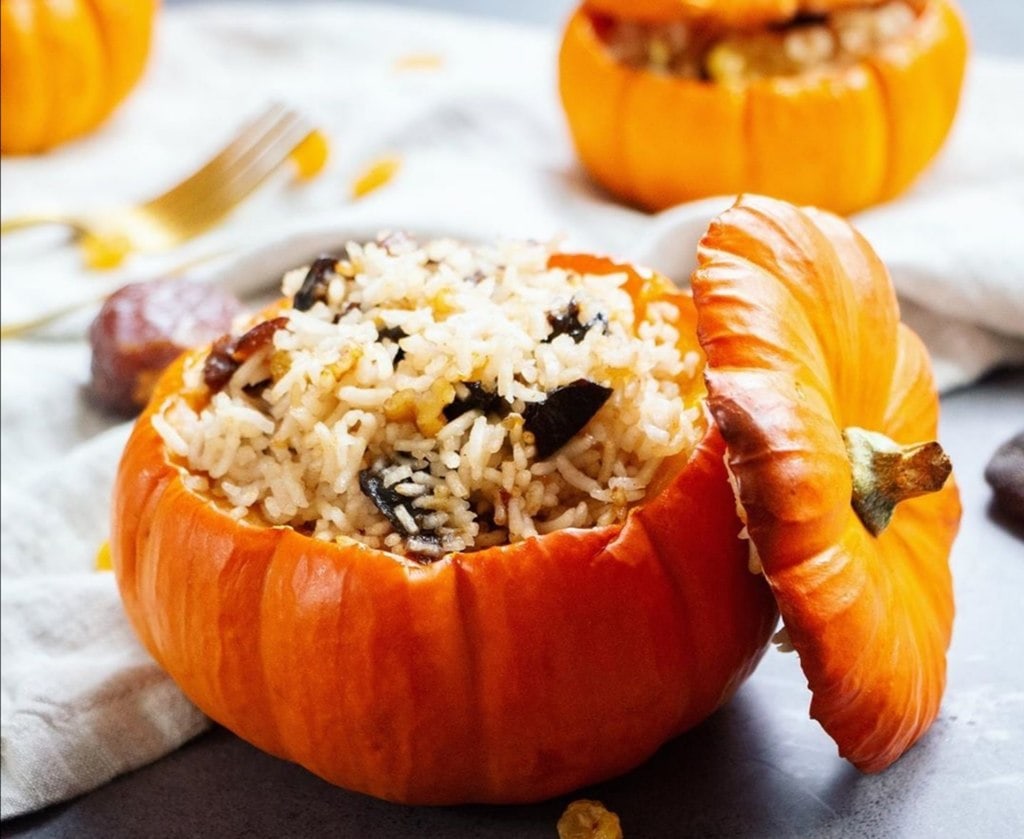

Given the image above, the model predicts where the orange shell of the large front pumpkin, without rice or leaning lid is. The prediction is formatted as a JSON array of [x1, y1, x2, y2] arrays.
[[112, 255, 777, 804]]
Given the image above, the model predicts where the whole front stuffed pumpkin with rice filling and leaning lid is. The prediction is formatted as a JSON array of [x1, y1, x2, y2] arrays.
[[111, 198, 958, 804]]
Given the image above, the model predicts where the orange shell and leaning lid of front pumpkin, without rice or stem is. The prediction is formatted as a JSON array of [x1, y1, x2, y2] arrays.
[[112, 193, 956, 803]]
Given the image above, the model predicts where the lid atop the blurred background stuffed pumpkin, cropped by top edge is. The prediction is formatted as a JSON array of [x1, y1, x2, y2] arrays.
[[585, 0, 887, 26]]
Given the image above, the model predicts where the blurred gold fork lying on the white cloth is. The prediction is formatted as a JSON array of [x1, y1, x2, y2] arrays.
[[0, 104, 327, 268]]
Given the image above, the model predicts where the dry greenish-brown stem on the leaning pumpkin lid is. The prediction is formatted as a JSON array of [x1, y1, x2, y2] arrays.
[[843, 426, 952, 536]]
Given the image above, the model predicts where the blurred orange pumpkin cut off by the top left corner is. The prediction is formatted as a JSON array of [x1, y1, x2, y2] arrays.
[[0, 0, 159, 154]]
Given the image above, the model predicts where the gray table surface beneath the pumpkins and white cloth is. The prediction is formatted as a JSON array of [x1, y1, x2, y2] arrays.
[[2, 0, 1024, 839]]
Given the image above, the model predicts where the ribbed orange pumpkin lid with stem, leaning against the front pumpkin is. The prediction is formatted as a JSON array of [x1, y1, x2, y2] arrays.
[[692, 197, 959, 771]]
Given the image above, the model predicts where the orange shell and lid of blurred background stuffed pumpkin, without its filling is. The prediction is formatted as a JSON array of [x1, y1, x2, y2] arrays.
[[559, 0, 967, 213]]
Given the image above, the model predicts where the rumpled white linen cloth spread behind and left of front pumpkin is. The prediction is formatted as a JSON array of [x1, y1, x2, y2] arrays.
[[0, 2, 1024, 819]]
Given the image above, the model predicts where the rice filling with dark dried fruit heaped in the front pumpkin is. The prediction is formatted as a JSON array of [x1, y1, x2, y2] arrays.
[[153, 235, 702, 561]]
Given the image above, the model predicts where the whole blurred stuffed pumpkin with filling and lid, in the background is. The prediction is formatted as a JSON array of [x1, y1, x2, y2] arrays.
[[559, 0, 968, 213]]
